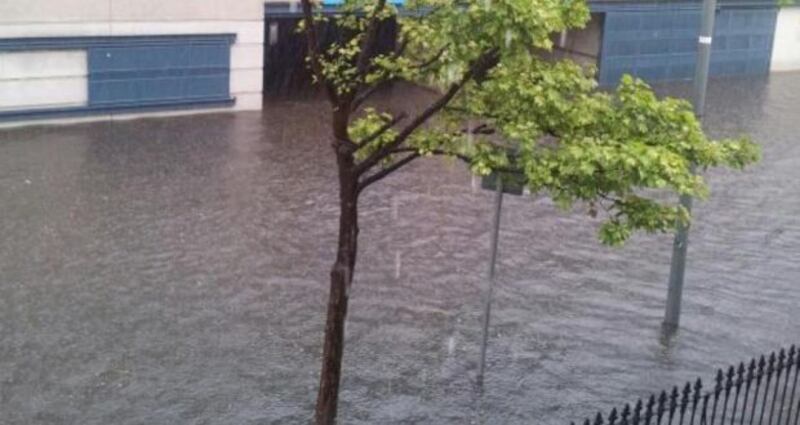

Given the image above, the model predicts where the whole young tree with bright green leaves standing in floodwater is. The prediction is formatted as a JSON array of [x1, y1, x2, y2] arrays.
[[301, 0, 758, 425]]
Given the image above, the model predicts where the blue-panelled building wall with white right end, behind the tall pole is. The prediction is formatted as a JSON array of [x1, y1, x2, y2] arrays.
[[562, 0, 800, 86]]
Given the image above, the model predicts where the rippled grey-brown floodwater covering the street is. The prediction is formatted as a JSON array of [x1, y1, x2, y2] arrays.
[[0, 73, 800, 425]]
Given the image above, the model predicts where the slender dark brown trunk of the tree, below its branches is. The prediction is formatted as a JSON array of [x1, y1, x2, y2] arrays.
[[315, 138, 358, 425]]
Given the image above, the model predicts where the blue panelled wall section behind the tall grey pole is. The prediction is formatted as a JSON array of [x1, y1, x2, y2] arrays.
[[593, 0, 778, 85]]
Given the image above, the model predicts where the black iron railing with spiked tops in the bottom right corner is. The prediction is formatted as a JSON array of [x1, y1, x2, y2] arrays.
[[572, 346, 800, 425]]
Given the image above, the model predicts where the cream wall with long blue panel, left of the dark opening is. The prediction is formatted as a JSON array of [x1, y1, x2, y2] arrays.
[[0, 0, 264, 123]]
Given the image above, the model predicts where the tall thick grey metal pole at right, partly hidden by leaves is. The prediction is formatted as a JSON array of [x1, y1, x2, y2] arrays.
[[664, 0, 717, 330]]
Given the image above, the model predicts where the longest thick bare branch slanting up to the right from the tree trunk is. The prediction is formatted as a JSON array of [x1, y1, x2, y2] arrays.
[[356, 49, 500, 175]]
